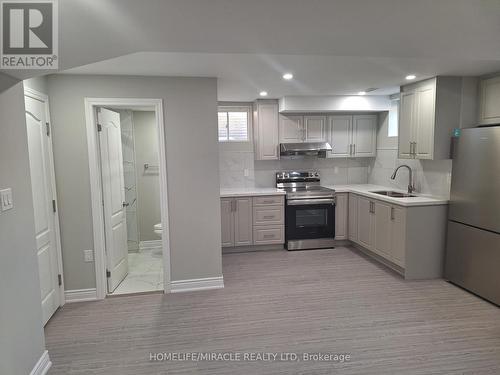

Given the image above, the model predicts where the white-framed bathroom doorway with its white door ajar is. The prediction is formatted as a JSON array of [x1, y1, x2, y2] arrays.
[[86, 99, 170, 298]]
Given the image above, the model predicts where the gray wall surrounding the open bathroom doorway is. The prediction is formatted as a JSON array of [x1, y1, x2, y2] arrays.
[[48, 75, 222, 290]]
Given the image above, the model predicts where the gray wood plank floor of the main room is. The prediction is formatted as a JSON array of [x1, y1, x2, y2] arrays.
[[46, 247, 500, 375]]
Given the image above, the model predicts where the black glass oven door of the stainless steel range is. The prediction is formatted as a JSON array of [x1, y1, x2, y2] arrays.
[[285, 198, 335, 241]]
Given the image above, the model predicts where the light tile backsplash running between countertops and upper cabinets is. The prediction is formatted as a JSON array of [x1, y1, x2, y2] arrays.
[[219, 148, 451, 199]]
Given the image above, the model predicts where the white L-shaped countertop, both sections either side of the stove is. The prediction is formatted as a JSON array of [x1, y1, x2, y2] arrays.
[[220, 184, 448, 207]]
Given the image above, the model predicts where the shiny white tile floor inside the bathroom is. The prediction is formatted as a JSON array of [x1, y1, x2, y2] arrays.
[[111, 248, 163, 296]]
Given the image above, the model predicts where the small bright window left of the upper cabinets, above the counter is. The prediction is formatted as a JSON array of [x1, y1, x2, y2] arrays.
[[218, 107, 251, 142]]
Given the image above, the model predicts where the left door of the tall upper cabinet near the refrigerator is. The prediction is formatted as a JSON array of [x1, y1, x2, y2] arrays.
[[398, 91, 417, 159]]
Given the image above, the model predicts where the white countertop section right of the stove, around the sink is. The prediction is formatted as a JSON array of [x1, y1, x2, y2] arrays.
[[325, 184, 448, 207]]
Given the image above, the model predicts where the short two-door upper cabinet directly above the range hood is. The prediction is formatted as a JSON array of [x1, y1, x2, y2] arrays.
[[279, 115, 327, 143]]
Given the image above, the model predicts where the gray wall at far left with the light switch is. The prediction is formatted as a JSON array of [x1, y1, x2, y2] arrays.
[[0, 78, 45, 374]]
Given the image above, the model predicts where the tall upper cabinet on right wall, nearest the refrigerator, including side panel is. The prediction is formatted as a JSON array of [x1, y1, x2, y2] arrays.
[[398, 77, 462, 160]]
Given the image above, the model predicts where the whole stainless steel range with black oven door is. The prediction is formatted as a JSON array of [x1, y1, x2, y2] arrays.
[[276, 171, 335, 250]]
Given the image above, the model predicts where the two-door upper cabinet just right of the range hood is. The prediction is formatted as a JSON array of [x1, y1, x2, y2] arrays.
[[328, 115, 377, 158]]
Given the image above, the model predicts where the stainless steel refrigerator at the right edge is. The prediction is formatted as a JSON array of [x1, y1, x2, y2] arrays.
[[445, 126, 500, 305]]
